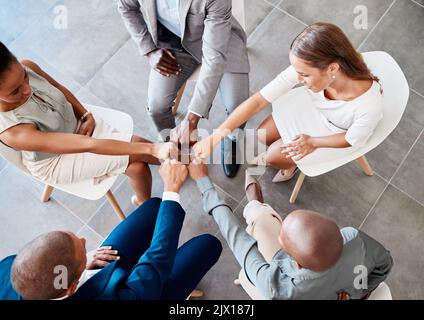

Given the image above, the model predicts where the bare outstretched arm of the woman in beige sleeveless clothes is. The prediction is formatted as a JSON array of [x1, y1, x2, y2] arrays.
[[0, 124, 155, 155]]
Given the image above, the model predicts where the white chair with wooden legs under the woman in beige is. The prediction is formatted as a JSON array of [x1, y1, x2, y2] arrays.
[[0, 105, 134, 220]]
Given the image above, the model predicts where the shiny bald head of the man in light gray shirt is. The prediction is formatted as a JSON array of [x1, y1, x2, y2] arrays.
[[280, 210, 343, 272]]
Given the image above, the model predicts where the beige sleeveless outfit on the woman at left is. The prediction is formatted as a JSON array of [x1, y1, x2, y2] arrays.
[[0, 68, 132, 184]]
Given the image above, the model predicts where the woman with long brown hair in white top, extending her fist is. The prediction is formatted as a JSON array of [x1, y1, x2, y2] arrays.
[[194, 23, 383, 182]]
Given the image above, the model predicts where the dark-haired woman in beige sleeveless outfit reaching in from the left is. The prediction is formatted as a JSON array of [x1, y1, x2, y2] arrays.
[[0, 42, 175, 205]]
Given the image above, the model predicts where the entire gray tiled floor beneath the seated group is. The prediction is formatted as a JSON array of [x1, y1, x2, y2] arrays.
[[0, 0, 424, 299]]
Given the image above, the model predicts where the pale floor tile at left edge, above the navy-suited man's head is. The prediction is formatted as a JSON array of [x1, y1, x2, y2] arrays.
[[0, 166, 82, 257]]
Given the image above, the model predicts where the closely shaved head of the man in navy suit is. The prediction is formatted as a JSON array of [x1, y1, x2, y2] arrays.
[[11, 231, 85, 300]]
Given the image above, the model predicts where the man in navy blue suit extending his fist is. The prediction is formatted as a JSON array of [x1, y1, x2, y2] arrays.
[[0, 160, 222, 300]]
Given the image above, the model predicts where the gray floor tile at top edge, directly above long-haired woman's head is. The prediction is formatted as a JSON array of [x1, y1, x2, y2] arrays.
[[279, 0, 392, 46]]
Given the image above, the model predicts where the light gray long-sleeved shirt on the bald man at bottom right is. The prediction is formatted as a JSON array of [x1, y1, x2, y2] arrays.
[[197, 177, 393, 300]]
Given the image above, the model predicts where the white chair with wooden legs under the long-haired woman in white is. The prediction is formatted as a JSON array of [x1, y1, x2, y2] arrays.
[[290, 51, 409, 203]]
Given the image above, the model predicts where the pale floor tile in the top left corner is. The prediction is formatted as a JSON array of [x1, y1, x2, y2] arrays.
[[0, 0, 58, 44]]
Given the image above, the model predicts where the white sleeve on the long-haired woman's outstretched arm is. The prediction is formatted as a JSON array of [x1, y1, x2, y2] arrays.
[[260, 66, 299, 103]]
